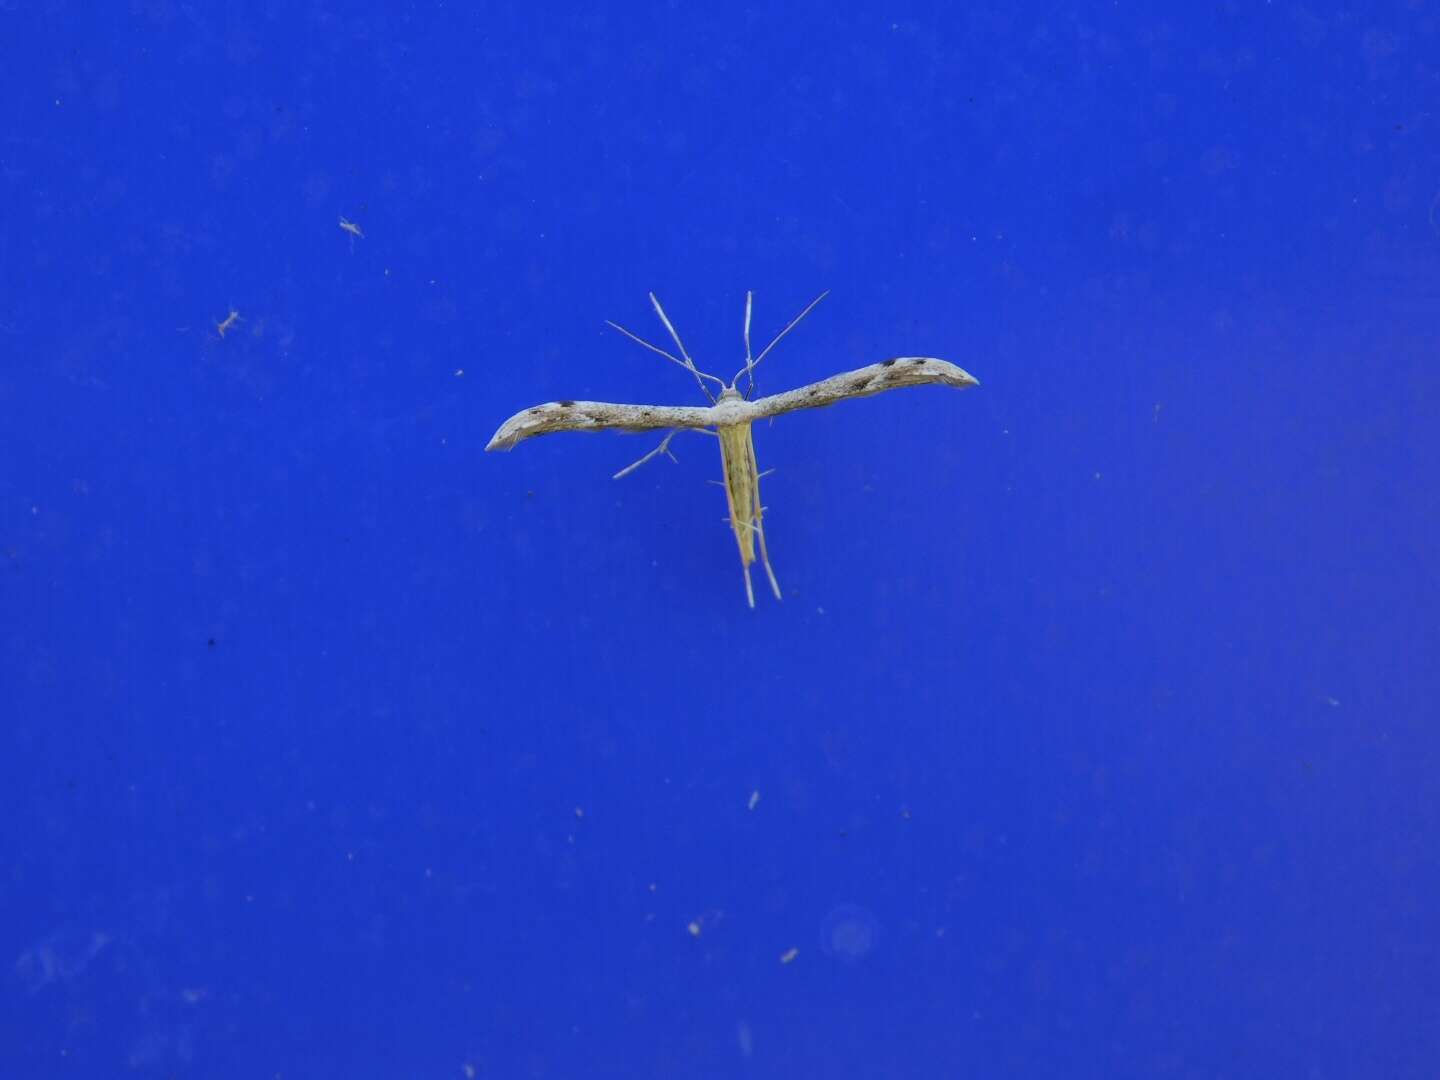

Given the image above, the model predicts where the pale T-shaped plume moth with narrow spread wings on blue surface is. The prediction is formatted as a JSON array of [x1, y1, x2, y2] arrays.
[[485, 291, 979, 608]]
